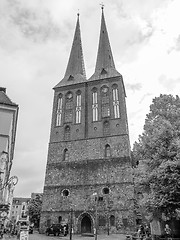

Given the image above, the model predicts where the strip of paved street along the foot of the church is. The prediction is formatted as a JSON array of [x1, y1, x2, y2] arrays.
[[3, 233, 126, 240]]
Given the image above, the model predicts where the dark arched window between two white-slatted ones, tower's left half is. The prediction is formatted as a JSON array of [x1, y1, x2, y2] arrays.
[[64, 92, 73, 123]]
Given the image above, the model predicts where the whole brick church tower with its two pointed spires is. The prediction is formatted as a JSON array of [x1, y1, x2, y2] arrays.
[[41, 7, 134, 234]]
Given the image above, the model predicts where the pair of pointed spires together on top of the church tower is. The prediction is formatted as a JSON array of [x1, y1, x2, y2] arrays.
[[55, 7, 120, 88]]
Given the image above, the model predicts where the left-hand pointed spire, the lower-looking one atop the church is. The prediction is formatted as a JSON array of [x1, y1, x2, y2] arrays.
[[55, 13, 86, 88]]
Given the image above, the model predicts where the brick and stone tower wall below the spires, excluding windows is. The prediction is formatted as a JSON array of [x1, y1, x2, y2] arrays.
[[40, 77, 134, 233]]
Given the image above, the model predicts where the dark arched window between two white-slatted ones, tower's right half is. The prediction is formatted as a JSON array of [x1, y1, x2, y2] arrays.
[[101, 86, 110, 117]]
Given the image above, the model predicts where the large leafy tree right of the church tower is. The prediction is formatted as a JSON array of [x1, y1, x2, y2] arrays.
[[133, 94, 180, 218]]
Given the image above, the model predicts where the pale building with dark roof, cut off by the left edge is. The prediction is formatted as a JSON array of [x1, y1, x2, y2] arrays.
[[0, 87, 18, 212]]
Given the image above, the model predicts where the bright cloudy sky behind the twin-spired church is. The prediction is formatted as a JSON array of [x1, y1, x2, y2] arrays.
[[0, 0, 180, 197]]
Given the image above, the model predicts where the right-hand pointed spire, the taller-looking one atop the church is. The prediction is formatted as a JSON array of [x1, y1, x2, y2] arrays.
[[89, 4, 121, 80]]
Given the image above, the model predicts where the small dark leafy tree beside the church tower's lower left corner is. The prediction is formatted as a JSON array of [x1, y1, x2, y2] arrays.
[[28, 194, 42, 228]]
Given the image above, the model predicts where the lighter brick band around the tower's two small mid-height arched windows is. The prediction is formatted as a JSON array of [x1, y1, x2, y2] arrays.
[[48, 135, 130, 163]]
